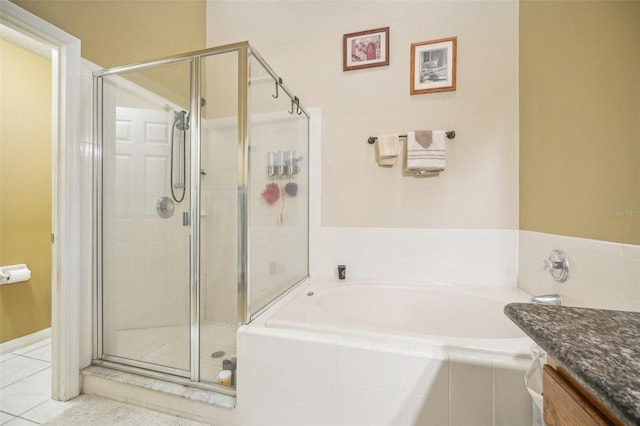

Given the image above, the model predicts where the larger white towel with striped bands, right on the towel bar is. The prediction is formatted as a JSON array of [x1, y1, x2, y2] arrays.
[[407, 130, 447, 173]]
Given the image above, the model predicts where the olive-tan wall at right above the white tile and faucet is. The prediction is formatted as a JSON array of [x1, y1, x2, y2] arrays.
[[520, 1, 640, 244]]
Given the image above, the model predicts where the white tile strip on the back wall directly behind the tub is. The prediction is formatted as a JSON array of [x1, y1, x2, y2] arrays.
[[310, 227, 518, 286]]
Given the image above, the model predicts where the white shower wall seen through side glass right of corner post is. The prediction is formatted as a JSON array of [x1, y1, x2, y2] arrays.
[[248, 112, 309, 312]]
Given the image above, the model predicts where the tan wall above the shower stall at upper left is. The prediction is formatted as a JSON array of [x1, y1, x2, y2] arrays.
[[12, 0, 205, 68]]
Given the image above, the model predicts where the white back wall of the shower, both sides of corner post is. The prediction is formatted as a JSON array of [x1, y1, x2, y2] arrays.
[[201, 114, 308, 324]]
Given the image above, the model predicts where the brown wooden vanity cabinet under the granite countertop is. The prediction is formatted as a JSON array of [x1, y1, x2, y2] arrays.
[[543, 357, 624, 426]]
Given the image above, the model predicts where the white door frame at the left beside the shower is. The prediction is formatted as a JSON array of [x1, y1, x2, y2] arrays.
[[0, 0, 82, 401]]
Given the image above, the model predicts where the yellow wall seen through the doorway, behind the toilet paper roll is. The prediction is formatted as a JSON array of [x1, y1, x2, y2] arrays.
[[0, 40, 51, 343]]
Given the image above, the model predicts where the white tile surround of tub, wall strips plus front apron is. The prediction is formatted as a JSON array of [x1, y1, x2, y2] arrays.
[[230, 227, 640, 425]]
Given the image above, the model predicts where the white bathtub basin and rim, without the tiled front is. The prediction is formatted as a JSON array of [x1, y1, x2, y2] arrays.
[[266, 280, 531, 357]]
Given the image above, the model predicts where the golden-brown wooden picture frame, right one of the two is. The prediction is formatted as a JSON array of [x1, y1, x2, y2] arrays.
[[411, 37, 458, 95]]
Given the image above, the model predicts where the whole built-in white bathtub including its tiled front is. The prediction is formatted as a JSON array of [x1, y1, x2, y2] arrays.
[[238, 279, 532, 425]]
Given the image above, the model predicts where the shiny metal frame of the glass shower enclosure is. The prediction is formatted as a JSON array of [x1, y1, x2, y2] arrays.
[[93, 41, 310, 395]]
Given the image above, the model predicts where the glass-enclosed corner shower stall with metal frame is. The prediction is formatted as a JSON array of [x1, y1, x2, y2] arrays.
[[94, 42, 309, 394]]
